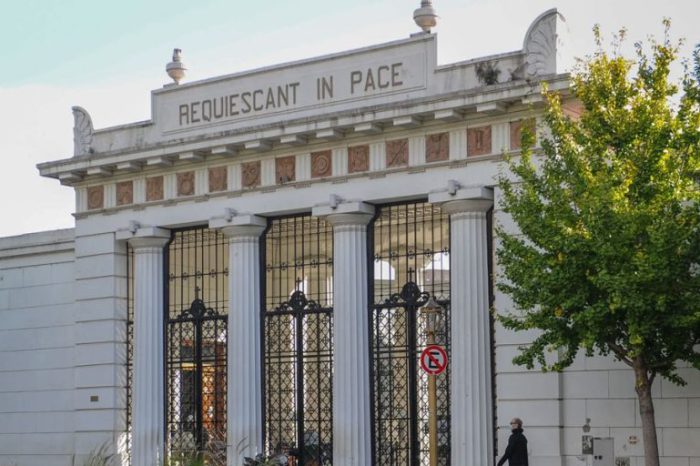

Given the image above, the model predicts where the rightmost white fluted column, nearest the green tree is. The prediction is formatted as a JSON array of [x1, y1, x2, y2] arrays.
[[430, 187, 493, 466]]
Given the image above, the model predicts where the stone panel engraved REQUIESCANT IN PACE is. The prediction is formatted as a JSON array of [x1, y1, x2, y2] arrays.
[[167, 58, 426, 131]]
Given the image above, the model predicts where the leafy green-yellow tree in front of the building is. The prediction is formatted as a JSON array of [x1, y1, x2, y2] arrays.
[[496, 21, 700, 466]]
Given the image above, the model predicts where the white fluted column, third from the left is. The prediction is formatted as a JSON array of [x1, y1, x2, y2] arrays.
[[313, 202, 374, 466]]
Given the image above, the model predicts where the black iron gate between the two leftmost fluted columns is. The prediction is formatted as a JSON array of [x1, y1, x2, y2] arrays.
[[166, 228, 228, 466]]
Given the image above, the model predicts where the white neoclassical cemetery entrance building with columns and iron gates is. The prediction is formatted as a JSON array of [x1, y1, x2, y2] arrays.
[[0, 6, 700, 466]]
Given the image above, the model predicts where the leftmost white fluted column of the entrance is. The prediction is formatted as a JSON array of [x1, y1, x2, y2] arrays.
[[128, 227, 170, 466]]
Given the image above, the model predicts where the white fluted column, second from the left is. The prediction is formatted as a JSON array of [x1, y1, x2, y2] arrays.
[[209, 215, 267, 466]]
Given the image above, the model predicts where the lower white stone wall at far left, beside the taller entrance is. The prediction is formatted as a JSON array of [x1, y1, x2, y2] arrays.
[[0, 229, 75, 466]]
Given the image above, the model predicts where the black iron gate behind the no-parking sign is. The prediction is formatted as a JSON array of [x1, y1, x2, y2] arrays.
[[368, 202, 450, 466]]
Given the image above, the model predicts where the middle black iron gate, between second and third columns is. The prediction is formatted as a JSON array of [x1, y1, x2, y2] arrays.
[[262, 216, 333, 466]]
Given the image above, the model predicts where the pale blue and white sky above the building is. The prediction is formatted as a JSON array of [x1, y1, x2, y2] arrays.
[[0, 0, 700, 237]]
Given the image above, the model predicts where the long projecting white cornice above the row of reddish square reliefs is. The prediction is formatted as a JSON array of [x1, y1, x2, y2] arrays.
[[37, 74, 569, 186]]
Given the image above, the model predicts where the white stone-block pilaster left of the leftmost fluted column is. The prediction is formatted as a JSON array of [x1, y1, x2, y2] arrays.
[[73, 232, 127, 464]]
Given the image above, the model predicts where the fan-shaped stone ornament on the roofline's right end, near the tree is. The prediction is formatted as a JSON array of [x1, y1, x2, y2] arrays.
[[523, 8, 565, 78]]
